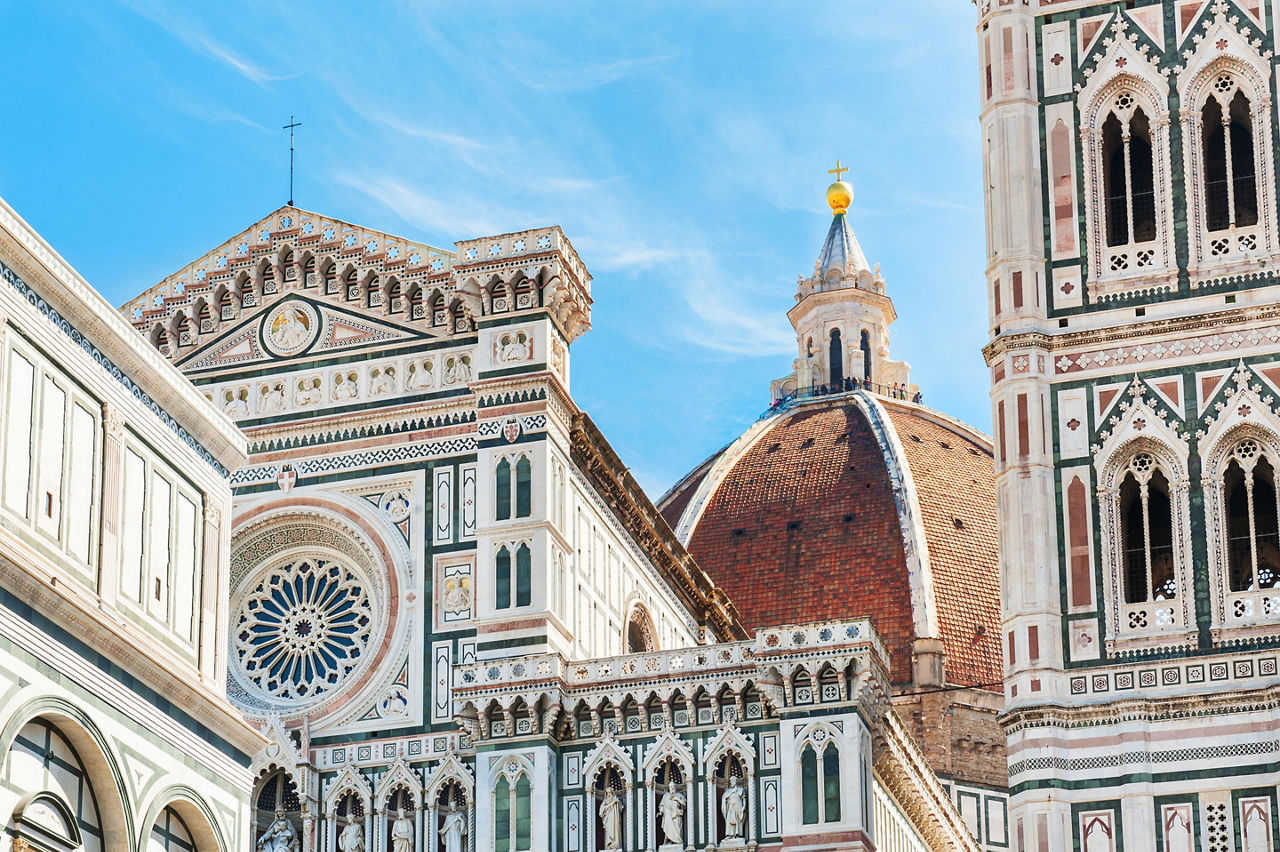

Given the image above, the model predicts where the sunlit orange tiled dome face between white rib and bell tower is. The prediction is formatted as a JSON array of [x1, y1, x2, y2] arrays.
[[884, 400, 1004, 688]]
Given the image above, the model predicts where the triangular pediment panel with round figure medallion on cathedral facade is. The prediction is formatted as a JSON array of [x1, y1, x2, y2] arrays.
[[177, 294, 431, 374]]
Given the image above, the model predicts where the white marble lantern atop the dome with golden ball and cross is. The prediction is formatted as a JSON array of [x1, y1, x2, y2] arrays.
[[771, 168, 918, 402]]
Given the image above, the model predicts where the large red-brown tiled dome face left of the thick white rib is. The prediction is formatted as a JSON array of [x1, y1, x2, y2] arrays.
[[689, 403, 914, 683]]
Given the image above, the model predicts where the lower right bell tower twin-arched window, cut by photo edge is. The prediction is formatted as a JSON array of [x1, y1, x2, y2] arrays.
[[1222, 439, 1280, 591]]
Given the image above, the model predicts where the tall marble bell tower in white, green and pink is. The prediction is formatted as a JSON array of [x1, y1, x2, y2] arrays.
[[977, 0, 1280, 852]]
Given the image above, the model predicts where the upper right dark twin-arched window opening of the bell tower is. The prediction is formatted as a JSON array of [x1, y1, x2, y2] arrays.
[[1201, 80, 1258, 232]]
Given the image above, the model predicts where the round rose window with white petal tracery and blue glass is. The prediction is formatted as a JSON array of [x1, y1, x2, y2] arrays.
[[233, 559, 374, 701]]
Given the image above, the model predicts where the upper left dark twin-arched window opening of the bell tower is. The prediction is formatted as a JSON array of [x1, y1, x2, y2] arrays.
[[1102, 100, 1156, 246]]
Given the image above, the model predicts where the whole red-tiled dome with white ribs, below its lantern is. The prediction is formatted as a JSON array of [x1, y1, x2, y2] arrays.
[[659, 390, 1002, 686]]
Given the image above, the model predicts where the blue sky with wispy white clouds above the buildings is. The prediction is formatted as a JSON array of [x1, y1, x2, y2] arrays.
[[0, 0, 989, 498]]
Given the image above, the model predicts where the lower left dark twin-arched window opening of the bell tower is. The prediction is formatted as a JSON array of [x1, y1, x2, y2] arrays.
[[1120, 453, 1178, 603]]
